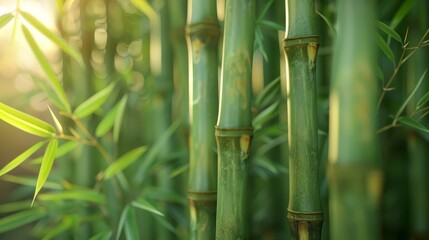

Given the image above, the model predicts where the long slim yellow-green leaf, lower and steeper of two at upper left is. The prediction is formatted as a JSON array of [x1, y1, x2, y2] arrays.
[[22, 25, 70, 112]]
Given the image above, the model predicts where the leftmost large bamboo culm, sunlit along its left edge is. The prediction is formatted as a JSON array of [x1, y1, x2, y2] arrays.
[[187, 0, 220, 240]]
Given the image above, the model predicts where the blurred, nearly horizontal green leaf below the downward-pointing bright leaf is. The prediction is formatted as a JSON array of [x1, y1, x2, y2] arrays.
[[38, 189, 106, 204]]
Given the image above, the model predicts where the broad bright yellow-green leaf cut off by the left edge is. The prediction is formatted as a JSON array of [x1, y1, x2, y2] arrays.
[[0, 102, 55, 137]]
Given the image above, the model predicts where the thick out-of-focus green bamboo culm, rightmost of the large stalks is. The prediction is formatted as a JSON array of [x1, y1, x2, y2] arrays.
[[327, 0, 381, 240]]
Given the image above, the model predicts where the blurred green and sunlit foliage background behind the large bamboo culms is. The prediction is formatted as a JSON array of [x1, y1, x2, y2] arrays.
[[0, 0, 429, 239]]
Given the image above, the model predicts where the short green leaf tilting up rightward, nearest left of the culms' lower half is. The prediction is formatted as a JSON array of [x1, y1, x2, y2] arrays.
[[104, 146, 147, 179]]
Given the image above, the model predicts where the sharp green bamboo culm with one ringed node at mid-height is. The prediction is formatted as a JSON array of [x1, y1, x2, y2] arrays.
[[216, 0, 255, 240]]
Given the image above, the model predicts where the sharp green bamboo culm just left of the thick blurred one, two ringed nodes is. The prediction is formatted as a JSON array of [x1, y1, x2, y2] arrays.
[[284, 0, 323, 239]]
